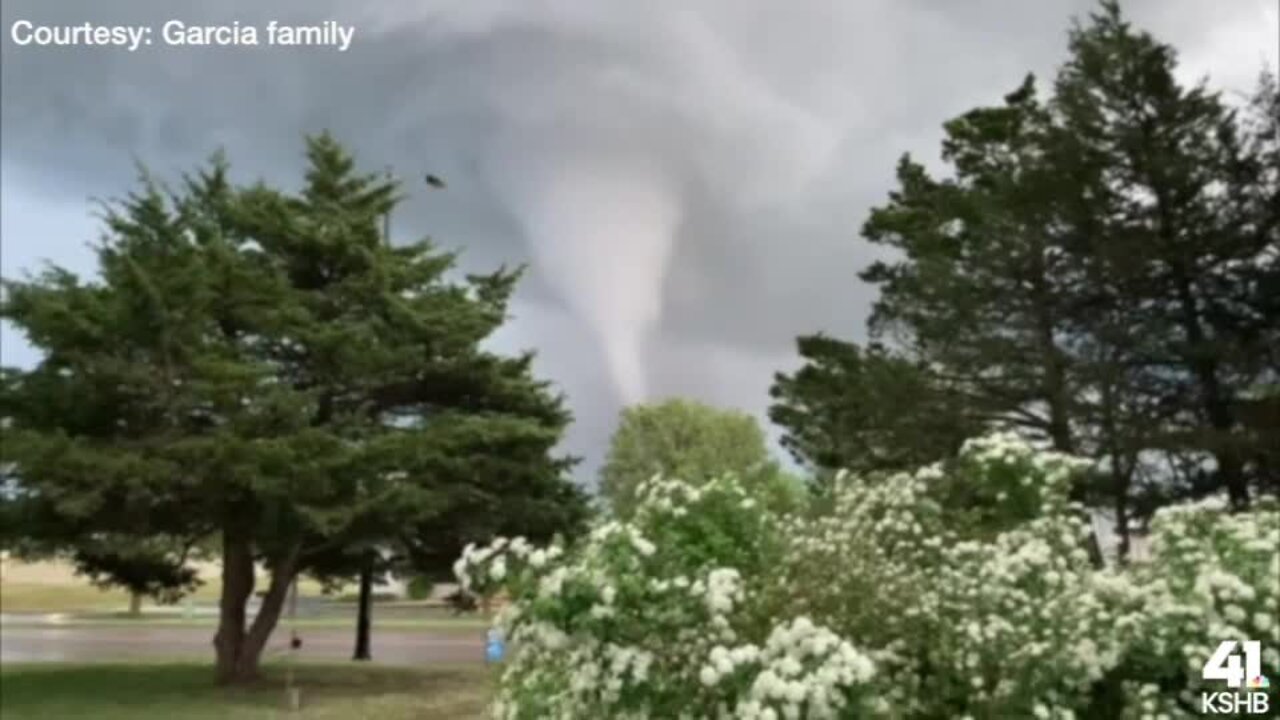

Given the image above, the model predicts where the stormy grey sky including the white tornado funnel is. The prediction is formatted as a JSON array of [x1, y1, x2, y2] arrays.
[[0, 0, 1280, 483]]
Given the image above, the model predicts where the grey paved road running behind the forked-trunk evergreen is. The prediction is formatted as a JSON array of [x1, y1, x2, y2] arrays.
[[0, 624, 484, 665]]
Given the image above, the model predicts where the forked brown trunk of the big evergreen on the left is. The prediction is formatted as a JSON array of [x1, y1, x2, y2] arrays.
[[214, 530, 298, 685]]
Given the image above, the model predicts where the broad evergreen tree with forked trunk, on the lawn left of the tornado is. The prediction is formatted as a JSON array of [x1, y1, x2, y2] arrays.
[[0, 136, 577, 683]]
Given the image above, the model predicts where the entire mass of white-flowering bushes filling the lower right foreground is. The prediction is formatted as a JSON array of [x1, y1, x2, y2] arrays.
[[456, 434, 1280, 720]]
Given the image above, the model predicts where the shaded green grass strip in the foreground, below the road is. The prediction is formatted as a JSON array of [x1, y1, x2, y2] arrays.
[[0, 664, 492, 720]]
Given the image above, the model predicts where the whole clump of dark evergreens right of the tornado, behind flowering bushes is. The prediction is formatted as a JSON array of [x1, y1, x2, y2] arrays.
[[773, 1, 1280, 552]]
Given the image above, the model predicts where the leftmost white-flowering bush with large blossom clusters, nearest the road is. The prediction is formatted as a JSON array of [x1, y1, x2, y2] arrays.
[[456, 478, 873, 719]]
